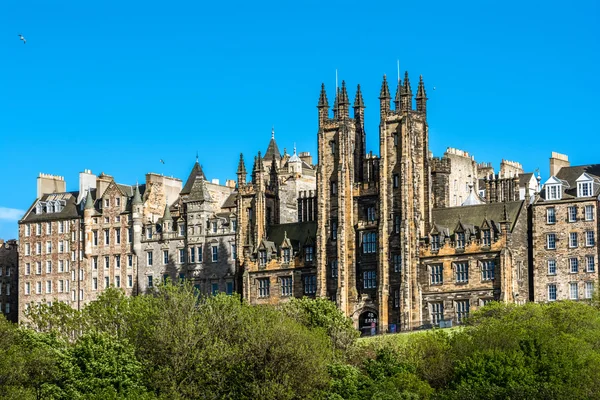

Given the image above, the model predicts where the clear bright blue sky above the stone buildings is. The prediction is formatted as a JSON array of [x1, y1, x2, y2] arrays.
[[0, 0, 600, 238]]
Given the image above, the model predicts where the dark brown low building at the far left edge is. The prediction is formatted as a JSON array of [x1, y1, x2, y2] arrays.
[[0, 239, 19, 322]]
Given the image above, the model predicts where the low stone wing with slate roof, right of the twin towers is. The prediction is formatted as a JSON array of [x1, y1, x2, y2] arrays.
[[418, 201, 529, 326]]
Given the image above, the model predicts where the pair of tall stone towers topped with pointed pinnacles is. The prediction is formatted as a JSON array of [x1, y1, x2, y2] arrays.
[[316, 73, 431, 332]]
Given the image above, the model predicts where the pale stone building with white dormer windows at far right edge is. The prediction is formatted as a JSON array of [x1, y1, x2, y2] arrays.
[[531, 153, 600, 302]]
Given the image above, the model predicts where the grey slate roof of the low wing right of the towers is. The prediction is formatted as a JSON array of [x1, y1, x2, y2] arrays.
[[432, 201, 525, 234]]
